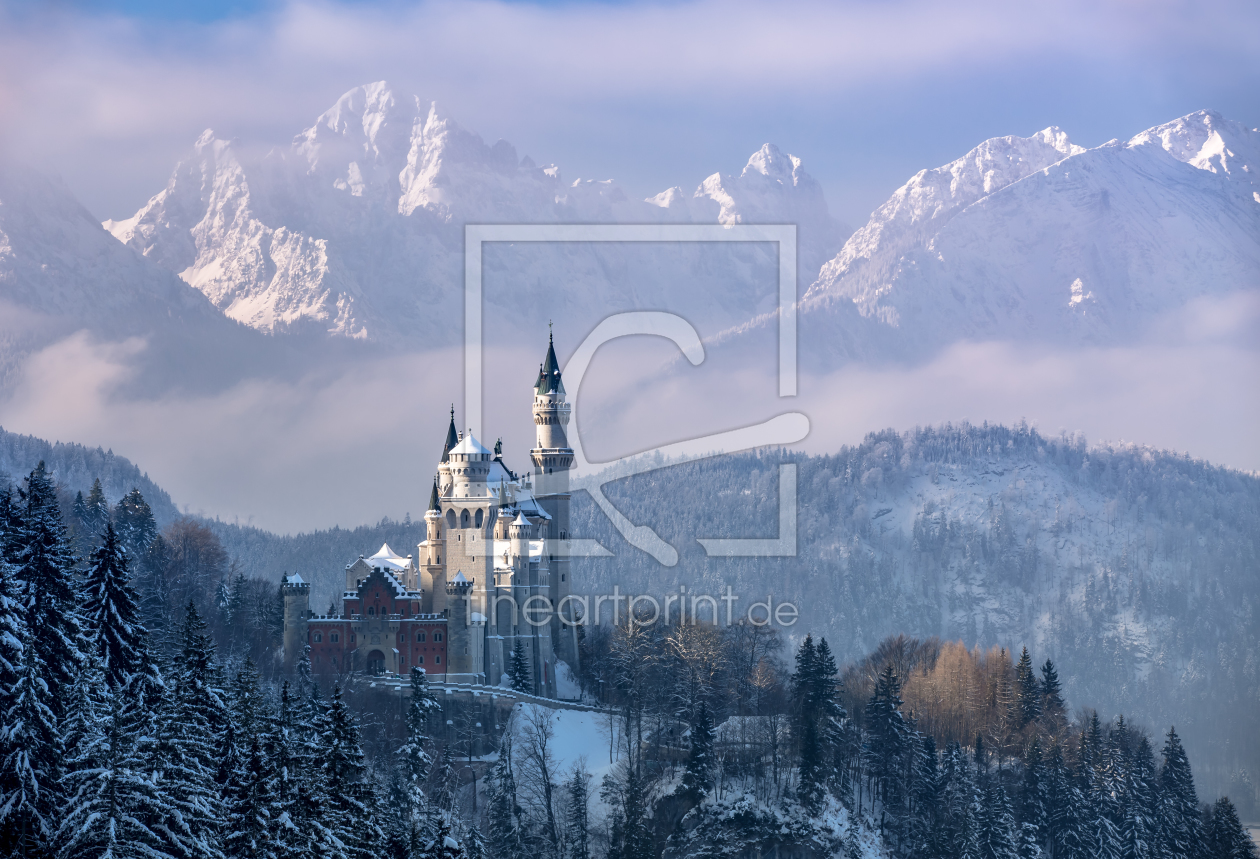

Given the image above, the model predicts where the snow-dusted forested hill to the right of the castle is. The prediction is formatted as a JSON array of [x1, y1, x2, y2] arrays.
[[573, 424, 1260, 807]]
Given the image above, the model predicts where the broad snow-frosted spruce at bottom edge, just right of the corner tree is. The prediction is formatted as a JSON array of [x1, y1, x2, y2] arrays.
[[57, 698, 168, 859]]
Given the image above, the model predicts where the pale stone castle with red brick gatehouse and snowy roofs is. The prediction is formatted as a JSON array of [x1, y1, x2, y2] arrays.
[[281, 329, 577, 698]]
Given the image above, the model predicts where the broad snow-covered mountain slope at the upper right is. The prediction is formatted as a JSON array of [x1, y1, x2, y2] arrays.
[[786, 111, 1260, 361]]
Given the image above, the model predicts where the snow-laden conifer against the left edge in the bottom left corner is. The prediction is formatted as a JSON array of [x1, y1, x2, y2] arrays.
[[0, 624, 63, 856]]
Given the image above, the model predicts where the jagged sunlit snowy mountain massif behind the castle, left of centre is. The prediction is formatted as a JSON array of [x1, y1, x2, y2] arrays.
[[105, 82, 843, 344]]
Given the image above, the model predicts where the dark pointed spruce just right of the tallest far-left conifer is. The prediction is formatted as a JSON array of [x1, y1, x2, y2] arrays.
[[83, 523, 147, 693]]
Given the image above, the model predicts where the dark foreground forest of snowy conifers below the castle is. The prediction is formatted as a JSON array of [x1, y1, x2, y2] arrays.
[[0, 462, 1256, 859]]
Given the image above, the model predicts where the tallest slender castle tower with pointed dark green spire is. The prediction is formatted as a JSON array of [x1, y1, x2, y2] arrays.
[[529, 327, 577, 673]]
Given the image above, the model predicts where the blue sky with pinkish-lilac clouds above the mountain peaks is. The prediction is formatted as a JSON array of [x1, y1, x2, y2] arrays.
[[0, 0, 1260, 227]]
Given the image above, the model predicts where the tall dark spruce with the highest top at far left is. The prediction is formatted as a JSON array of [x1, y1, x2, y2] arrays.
[[15, 462, 87, 719]]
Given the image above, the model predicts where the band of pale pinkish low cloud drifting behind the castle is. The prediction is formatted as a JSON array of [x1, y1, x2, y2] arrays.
[[0, 314, 1260, 532]]
